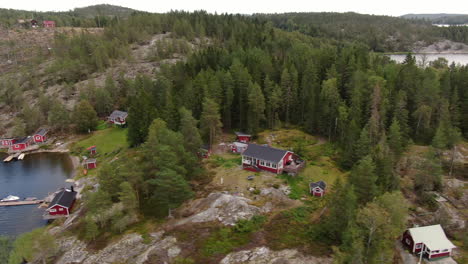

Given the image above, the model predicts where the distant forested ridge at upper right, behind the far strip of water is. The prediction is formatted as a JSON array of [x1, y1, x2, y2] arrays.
[[256, 13, 468, 52]]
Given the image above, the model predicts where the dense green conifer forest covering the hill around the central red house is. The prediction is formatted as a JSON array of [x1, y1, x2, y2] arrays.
[[0, 6, 468, 264]]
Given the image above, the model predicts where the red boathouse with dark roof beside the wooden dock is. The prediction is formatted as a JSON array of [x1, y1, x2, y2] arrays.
[[44, 187, 76, 219]]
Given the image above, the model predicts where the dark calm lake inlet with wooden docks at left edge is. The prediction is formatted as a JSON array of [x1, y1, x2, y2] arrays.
[[0, 153, 73, 236]]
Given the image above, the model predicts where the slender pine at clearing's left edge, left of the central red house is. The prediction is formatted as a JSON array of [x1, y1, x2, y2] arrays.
[[201, 98, 223, 147]]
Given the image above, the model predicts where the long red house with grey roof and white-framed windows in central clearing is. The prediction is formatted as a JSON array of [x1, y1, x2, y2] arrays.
[[242, 144, 304, 174]]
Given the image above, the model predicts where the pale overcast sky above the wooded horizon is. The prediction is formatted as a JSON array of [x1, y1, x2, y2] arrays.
[[0, 0, 468, 16]]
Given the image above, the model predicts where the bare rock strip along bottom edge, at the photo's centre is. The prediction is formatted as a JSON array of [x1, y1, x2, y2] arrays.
[[220, 247, 332, 264]]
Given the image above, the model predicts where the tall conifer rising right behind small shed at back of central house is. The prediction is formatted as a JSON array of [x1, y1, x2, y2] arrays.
[[247, 83, 265, 135]]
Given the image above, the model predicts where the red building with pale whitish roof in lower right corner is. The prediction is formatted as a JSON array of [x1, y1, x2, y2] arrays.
[[402, 225, 456, 260]]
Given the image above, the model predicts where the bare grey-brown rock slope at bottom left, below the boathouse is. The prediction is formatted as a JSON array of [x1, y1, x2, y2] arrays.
[[56, 232, 181, 264]]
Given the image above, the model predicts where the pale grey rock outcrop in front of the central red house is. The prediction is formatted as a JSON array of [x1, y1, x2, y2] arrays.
[[177, 193, 261, 225]]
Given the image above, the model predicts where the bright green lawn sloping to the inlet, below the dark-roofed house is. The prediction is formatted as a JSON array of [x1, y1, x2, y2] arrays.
[[72, 127, 128, 155]]
